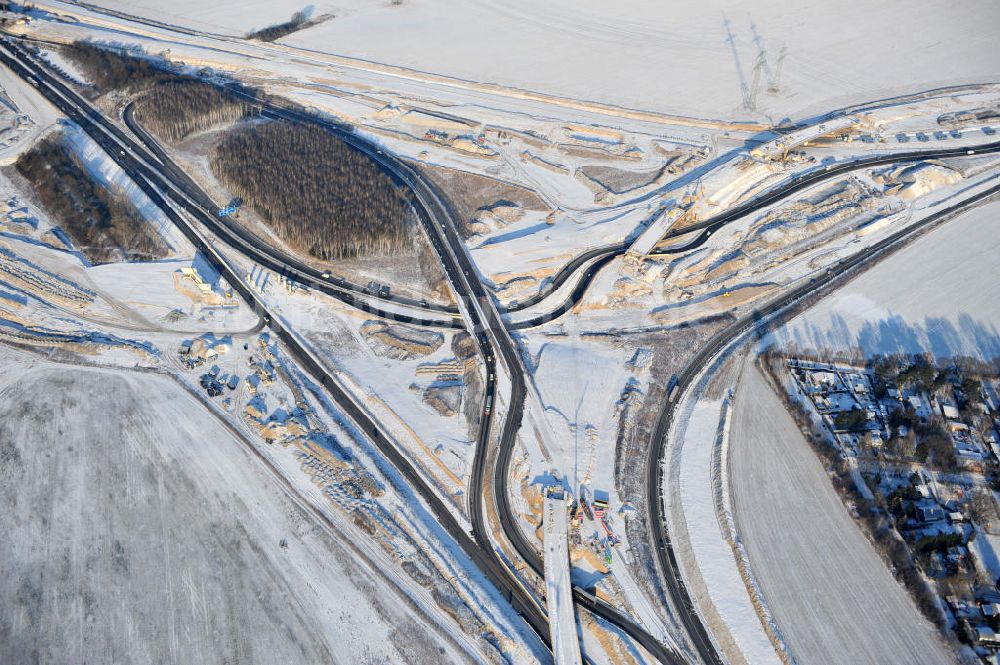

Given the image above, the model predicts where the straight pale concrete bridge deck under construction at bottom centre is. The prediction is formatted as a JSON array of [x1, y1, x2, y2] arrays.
[[543, 485, 581, 665]]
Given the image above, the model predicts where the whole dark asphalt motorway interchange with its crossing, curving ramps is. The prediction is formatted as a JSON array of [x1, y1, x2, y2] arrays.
[[7, 39, 1000, 663]]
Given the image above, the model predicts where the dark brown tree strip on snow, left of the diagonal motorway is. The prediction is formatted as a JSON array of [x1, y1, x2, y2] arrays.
[[15, 134, 167, 263]]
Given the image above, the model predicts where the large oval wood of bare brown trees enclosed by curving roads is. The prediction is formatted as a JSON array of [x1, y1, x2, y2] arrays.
[[211, 122, 413, 260]]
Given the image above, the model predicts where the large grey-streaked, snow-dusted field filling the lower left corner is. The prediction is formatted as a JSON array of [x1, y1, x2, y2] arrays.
[[0, 351, 469, 665]]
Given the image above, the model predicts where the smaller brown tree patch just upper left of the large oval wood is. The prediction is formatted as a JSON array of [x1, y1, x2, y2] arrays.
[[135, 80, 250, 143]]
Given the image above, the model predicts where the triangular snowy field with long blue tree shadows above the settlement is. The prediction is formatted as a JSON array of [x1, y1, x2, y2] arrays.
[[774, 197, 1000, 359]]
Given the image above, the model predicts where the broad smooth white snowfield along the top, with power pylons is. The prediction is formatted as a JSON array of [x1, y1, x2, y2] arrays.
[[66, 0, 1000, 120]]
